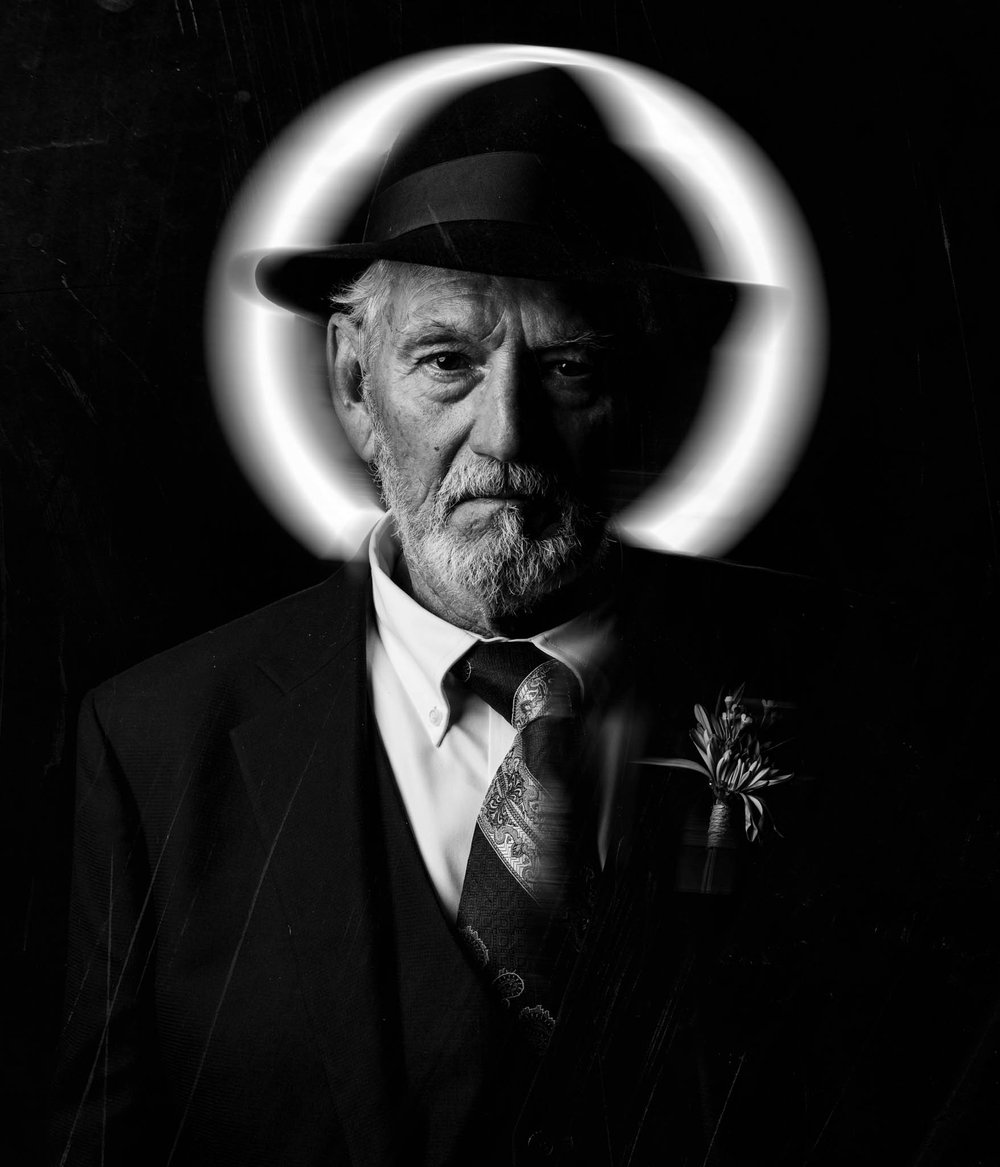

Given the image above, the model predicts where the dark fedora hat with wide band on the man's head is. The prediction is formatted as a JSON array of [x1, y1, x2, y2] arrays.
[[254, 67, 736, 343]]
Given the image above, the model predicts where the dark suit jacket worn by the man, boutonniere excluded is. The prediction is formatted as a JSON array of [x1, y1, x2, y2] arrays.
[[46, 554, 938, 1167]]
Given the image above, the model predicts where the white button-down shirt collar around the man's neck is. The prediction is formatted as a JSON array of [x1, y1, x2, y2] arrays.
[[369, 516, 614, 746]]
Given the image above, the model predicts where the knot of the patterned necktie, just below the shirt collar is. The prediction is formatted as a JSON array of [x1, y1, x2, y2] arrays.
[[455, 641, 580, 729]]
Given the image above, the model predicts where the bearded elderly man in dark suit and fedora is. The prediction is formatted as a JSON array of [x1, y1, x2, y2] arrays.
[[57, 70, 828, 1167]]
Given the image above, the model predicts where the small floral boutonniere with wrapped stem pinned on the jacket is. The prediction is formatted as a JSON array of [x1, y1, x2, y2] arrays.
[[644, 685, 793, 890]]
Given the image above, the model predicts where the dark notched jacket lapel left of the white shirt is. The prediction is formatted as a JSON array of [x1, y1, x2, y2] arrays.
[[232, 568, 397, 1163]]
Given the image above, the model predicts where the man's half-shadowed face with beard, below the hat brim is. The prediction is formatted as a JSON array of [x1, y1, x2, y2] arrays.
[[347, 268, 615, 627]]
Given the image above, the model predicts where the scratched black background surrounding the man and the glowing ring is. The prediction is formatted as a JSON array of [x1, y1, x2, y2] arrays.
[[0, 0, 1000, 1163]]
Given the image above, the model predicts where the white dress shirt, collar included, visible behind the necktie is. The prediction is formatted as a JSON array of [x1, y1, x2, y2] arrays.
[[368, 518, 614, 918]]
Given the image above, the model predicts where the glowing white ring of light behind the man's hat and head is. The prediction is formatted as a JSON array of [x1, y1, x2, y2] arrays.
[[207, 44, 826, 558]]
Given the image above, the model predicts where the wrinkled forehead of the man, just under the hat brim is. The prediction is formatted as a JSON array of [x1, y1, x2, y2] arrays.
[[386, 267, 616, 347]]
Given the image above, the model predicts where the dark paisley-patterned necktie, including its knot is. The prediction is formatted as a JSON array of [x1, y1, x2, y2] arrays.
[[455, 641, 597, 1051]]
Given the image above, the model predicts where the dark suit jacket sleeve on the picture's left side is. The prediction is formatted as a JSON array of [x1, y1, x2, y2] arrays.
[[50, 694, 172, 1167]]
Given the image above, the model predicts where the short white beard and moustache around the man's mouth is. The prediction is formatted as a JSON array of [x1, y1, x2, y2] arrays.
[[369, 394, 610, 617]]
